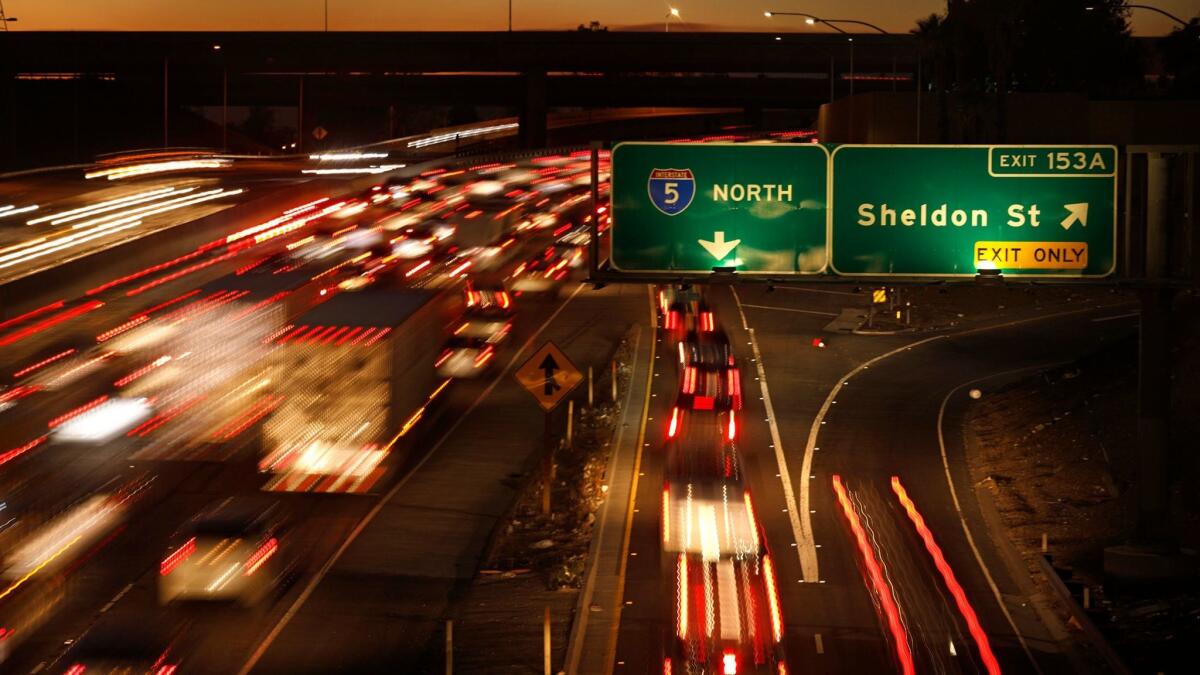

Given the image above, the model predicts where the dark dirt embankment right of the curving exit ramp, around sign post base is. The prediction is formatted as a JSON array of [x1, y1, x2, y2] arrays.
[[965, 290, 1200, 673]]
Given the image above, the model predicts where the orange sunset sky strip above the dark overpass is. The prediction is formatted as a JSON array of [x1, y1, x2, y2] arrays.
[[4, 0, 1196, 35]]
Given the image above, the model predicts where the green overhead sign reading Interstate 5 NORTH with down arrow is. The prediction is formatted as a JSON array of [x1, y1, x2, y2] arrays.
[[611, 143, 829, 274]]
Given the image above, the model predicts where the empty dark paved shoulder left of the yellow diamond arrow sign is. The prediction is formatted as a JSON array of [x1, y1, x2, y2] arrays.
[[237, 279, 646, 673]]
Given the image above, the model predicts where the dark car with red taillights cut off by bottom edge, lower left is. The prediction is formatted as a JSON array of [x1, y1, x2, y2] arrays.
[[61, 615, 182, 675]]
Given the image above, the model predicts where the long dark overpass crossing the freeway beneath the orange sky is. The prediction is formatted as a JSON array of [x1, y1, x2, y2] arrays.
[[0, 31, 918, 163]]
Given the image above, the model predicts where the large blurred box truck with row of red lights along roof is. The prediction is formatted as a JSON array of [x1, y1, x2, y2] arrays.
[[259, 285, 464, 492]]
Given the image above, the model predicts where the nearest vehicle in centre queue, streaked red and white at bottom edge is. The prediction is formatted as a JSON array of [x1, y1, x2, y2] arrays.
[[662, 550, 788, 675]]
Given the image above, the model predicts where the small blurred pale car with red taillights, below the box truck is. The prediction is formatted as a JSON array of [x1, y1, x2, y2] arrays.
[[158, 497, 288, 607]]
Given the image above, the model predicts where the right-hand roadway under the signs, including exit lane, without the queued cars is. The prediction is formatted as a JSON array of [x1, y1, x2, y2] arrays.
[[610, 287, 1135, 673]]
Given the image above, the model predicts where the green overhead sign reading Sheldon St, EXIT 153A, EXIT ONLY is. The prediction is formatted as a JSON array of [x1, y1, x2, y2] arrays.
[[829, 145, 1117, 277]]
